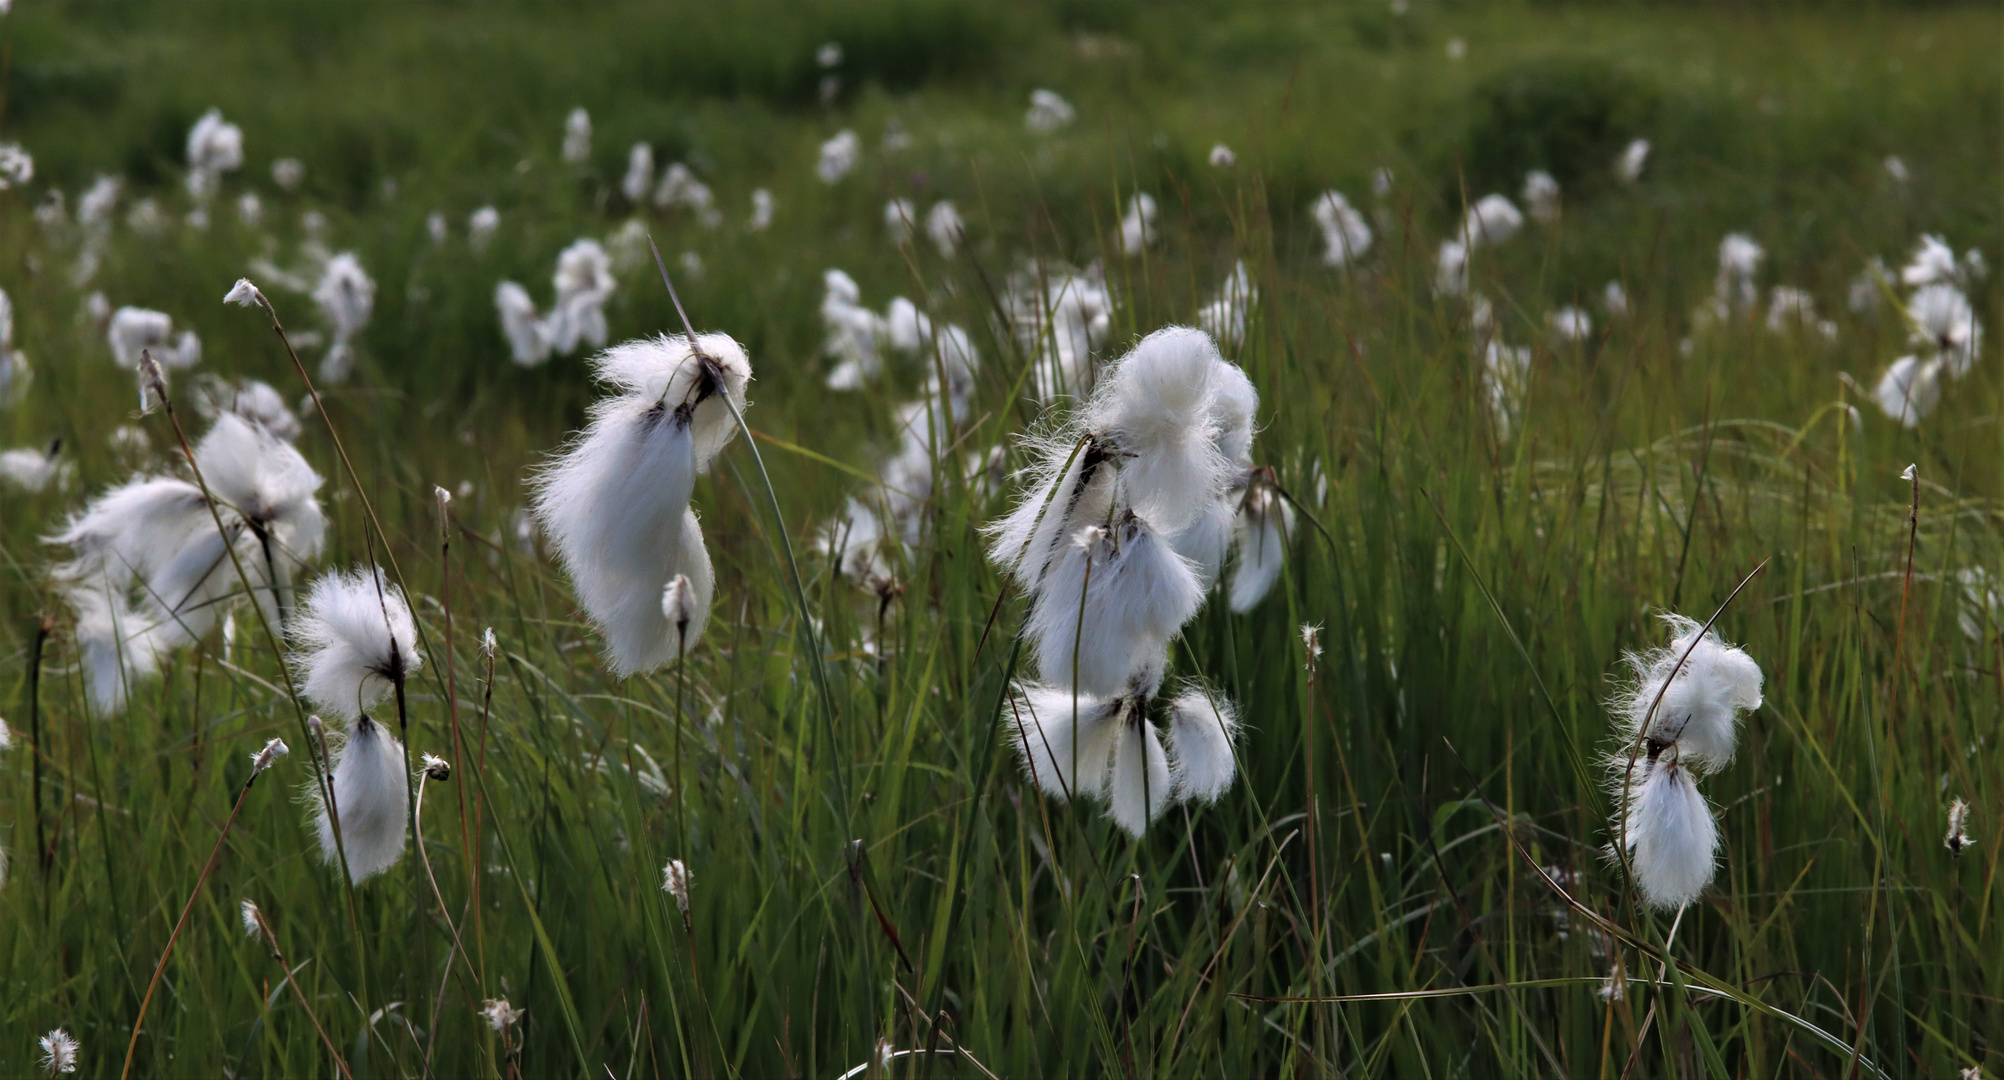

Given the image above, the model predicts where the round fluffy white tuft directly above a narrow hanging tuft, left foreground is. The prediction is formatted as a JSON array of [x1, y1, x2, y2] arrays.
[[291, 567, 425, 725]]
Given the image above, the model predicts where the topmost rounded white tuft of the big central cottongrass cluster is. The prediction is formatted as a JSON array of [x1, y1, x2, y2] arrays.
[[1086, 327, 1230, 533]]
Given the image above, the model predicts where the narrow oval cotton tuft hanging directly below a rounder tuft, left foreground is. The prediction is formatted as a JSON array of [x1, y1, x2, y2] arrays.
[[307, 717, 411, 884]]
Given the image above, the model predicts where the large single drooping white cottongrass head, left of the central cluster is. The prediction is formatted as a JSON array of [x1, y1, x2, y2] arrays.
[[533, 335, 752, 675]]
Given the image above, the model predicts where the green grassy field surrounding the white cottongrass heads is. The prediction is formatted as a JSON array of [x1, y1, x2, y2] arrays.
[[0, 0, 2004, 1080]]
